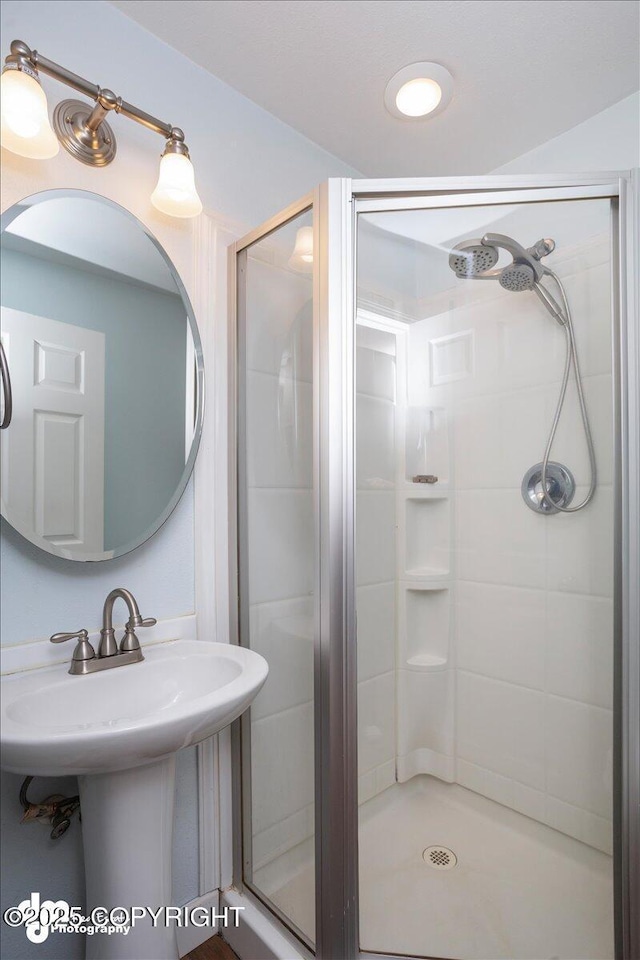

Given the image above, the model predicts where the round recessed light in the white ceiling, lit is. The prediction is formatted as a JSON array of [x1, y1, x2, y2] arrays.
[[384, 63, 453, 120]]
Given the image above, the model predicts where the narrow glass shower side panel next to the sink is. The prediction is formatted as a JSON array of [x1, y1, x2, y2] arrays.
[[238, 212, 315, 943]]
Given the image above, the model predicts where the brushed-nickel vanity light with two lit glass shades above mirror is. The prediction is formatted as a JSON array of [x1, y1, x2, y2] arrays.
[[1, 40, 202, 217]]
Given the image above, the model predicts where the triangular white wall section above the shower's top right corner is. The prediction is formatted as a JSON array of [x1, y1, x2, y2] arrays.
[[492, 92, 640, 173]]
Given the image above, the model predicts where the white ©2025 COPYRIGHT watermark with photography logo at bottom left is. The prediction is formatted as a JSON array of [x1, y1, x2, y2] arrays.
[[2, 892, 244, 943]]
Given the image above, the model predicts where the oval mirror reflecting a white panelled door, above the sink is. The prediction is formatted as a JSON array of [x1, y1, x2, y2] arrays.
[[1, 190, 204, 560]]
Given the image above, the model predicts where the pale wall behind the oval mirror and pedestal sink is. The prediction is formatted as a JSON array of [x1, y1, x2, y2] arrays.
[[1, 0, 354, 960]]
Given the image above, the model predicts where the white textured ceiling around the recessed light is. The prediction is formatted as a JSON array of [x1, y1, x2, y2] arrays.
[[107, 0, 640, 177]]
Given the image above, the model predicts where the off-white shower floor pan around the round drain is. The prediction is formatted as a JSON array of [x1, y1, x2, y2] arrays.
[[255, 776, 614, 960]]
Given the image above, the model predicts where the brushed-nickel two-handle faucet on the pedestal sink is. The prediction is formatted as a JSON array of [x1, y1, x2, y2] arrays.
[[49, 587, 157, 675]]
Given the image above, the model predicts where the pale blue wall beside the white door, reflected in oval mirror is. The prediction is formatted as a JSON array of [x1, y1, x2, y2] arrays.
[[1, 248, 186, 552]]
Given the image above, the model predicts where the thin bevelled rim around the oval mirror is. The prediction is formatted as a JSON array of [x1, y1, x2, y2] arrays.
[[0, 188, 205, 563]]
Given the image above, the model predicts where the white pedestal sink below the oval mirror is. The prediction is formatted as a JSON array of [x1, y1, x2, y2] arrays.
[[2, 640, 268, 960]]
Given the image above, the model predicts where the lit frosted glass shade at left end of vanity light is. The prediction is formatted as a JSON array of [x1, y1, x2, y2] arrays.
[[0, 70, 60, 160]]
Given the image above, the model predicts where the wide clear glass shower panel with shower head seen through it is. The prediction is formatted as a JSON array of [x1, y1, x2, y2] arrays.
[[355, 199, 614, 960]]
